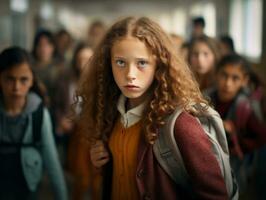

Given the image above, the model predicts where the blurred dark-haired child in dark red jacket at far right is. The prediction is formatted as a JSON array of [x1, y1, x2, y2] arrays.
[[209, 54, 266, 199]]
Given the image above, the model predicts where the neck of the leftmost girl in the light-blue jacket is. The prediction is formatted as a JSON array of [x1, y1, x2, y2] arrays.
[[4, 98, 26, 116]]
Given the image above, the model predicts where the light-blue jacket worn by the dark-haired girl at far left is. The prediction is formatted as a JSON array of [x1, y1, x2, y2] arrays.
[[0, 93, 67, 200]]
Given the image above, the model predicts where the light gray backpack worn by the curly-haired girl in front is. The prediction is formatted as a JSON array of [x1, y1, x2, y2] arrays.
[[153, 105, 238, 200]]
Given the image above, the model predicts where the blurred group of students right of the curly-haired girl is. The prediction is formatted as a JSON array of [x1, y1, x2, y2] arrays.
[[179, 17, 266, 199]]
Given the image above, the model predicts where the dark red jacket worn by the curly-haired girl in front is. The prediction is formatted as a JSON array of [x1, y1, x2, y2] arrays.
[[103, 112, 228, 200]]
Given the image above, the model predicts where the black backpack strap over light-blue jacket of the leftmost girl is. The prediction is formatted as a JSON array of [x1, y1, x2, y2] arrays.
[[32, 103, 44, 144]]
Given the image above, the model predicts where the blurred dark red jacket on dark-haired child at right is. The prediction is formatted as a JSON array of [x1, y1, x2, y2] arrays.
[[210, 90, 266, 155]]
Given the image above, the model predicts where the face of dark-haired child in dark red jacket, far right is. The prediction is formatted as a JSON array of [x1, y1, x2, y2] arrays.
[[217, 64, 248, 102]]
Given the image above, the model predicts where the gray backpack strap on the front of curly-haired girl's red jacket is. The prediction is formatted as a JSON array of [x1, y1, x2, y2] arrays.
[[153, 109, 189, 189]]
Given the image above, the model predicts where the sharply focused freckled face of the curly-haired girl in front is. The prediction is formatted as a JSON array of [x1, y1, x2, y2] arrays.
[[111, 37, 156, 107]]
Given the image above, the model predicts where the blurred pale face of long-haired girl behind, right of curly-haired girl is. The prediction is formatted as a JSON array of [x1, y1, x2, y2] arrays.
[[190, 42, 215, 75]]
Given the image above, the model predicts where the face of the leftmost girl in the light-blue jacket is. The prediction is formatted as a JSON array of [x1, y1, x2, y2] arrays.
[[0, 63, 33, 101]]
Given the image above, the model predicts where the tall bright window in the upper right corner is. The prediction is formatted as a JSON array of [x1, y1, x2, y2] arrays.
[[229, 0, 263, 61]]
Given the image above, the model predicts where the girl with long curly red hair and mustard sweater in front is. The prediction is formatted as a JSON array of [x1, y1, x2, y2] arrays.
[[77, 17, 228, 200]]
